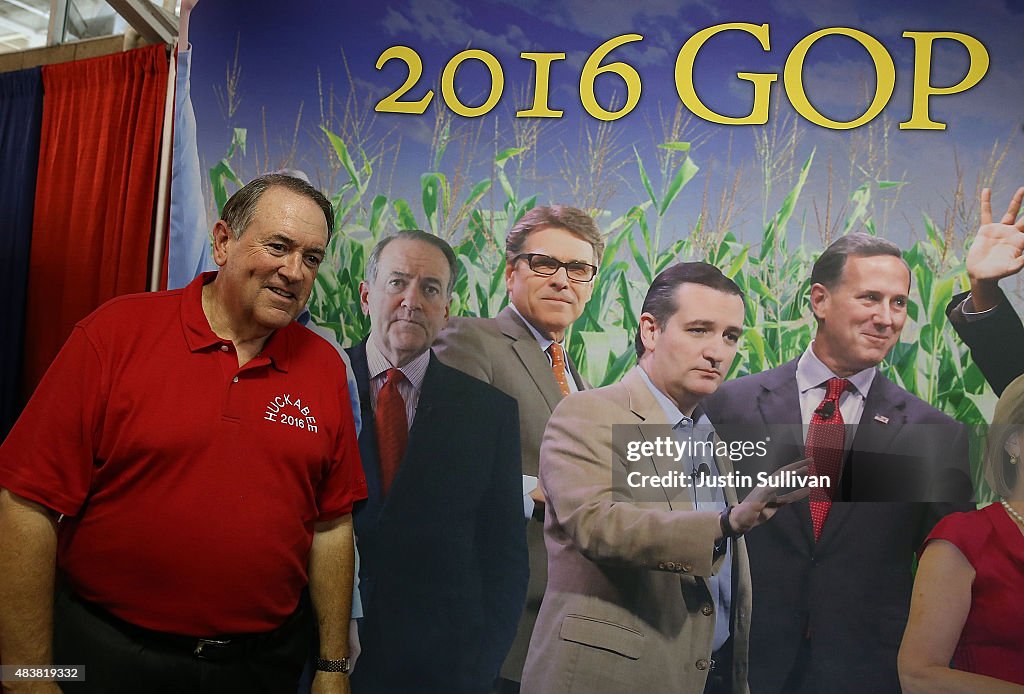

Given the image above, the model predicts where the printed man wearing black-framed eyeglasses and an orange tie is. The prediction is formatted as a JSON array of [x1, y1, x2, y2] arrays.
[[434, 205, 604, 693]]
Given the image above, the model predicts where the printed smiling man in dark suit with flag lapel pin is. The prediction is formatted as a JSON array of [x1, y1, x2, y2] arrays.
[[706, 233, 971, 694]]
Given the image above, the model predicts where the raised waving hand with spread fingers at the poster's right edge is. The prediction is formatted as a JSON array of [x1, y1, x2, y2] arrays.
[[967, 187, 1024, 311]]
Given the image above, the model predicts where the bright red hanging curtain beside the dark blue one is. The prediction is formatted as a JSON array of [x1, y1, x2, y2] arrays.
[[23, 45, 167, 398]]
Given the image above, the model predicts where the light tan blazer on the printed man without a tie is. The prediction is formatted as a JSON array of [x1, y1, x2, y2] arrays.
[[522, 370, 751, 694]]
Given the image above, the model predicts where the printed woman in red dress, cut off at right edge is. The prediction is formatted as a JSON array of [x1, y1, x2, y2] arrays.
[[899, 374, 1024, 694]]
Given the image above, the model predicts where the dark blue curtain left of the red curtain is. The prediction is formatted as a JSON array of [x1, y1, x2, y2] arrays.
[[0, 68, 43, 437]]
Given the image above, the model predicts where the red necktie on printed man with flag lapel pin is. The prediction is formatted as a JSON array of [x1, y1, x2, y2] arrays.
[[807, 379, 851, 539]]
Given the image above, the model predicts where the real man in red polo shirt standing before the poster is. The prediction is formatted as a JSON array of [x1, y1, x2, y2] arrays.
[[0, 175, 367, 693]]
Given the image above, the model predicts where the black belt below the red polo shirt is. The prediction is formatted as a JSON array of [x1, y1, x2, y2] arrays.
[[61, 591, 306, 661]]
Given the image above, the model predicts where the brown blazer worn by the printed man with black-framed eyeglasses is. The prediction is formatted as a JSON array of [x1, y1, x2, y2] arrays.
[[434, 307, 589, 682]]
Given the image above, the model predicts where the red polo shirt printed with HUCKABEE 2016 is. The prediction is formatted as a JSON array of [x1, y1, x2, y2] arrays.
[[0, 273, 367, 636]]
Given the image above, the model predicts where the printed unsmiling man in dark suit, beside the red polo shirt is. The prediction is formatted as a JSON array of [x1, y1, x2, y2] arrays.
[[349, 231, 528, 694]]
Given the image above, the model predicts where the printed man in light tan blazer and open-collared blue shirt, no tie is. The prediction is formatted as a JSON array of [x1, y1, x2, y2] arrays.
[[522, 263, 807, 694]]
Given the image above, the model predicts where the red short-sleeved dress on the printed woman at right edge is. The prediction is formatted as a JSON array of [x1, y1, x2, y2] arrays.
[[925, 504, 1024, 685]]
